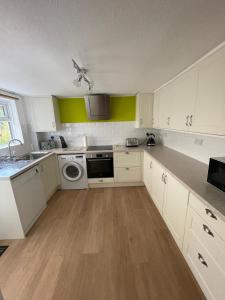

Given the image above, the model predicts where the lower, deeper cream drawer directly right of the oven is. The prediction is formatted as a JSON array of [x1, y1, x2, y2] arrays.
[[115, 167, 141, 182]]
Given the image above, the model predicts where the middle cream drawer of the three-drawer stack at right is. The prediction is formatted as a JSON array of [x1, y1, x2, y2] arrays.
[[189, 208, 225, 272]]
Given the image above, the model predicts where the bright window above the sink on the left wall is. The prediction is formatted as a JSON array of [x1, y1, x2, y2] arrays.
[[0, 98, 22, 148]]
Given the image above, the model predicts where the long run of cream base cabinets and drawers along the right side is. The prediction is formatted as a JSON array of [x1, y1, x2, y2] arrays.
[[143, 153, 225, 300]]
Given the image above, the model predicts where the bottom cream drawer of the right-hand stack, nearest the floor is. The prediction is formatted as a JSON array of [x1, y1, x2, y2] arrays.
[[186, 236, 225, 300]]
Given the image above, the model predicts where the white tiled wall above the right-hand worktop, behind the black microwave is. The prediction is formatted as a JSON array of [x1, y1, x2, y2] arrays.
[[156, 130, 225, 164]]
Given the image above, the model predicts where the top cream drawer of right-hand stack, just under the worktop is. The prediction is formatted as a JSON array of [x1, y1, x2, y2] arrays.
[[189, 193, 225, 241]]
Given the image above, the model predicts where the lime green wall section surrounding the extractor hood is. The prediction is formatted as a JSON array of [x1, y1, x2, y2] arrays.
[[58, 96, 136, 123]]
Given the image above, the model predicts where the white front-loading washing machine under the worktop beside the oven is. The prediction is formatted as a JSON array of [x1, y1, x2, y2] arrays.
[[58, 154, 88, 190]]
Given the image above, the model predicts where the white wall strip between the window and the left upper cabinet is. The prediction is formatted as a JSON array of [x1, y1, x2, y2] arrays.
[[0, 99, 31, 156]]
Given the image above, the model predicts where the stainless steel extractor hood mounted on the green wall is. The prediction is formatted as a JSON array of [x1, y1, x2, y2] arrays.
[[84, 94, 110, 120]]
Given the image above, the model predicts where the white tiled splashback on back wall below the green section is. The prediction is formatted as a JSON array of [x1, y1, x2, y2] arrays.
[[39, 122, 148, 147]]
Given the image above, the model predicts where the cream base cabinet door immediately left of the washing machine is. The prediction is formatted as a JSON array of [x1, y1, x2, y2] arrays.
[[39, 155, 59, 200]]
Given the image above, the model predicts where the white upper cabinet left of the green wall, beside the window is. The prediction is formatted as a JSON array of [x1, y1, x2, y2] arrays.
[[27, 96, 60, 132]]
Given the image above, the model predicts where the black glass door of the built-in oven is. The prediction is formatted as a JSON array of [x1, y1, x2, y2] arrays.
[[87, 158, 114, 178]]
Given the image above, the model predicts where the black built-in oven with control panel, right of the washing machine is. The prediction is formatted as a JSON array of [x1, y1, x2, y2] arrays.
[[86, 152, 114, 178]]
